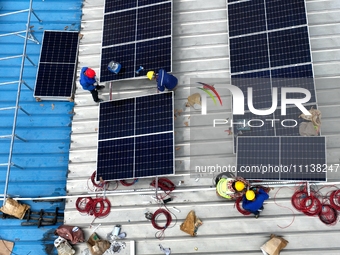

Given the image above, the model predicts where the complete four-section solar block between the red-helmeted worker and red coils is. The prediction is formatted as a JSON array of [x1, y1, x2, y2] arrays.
[[97, 92, 175, 180]]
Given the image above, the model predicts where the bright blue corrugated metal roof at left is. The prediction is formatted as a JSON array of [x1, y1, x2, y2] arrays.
[[0, 0, 82, 255]]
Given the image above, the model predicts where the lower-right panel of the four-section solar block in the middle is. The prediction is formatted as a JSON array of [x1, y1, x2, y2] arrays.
[[135, 132, 174, 178]]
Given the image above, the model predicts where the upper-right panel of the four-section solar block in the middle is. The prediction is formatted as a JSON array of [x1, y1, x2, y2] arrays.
[[136, 93, 174, 135]]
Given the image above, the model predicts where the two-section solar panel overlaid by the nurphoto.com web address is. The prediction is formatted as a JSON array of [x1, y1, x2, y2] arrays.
[[237, 137, 327, 181]]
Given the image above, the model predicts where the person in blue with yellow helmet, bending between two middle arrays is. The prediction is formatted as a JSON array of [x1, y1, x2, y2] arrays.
[[146, 69, 178, 92]]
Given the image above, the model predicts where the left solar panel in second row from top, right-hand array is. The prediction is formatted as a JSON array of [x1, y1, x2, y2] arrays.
[[230, 34, 269, 73]]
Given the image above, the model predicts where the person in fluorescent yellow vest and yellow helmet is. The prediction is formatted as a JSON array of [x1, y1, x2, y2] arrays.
[[216, 176, 249, 199]]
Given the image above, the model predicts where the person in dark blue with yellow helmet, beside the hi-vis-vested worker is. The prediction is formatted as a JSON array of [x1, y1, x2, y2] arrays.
[[242, 188, 269, 219]]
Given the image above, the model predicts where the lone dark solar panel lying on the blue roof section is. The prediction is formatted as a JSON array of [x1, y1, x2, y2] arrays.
[[34, 31, 79, 99]]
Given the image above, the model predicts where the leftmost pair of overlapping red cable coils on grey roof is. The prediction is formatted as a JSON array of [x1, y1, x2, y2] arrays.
[[76, 197, 111, 218]]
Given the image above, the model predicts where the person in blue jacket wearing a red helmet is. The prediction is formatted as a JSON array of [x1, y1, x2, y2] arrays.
[[79, 67, 105, 103]]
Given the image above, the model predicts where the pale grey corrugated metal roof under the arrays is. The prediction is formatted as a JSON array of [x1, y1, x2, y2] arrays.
[[65, 0, 340, 255]]
